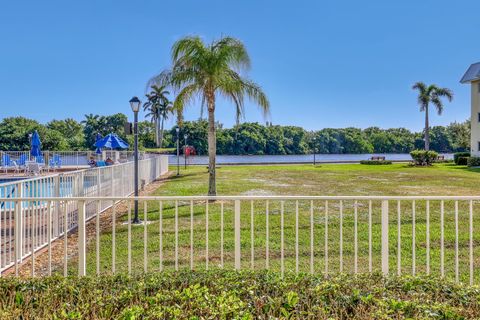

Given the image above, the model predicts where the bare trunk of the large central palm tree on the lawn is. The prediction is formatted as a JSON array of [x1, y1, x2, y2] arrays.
[[207, 93, 217, 196]]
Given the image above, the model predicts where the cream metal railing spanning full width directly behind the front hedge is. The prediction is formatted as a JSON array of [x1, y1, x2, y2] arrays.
[[0, 191, 480, 284]]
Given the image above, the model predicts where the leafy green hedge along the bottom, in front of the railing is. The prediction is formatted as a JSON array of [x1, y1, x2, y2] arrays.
[[0, 269, 480, 319]]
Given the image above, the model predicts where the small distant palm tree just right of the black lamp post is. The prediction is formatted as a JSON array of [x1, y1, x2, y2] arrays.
[[143, 85, 172, 148]]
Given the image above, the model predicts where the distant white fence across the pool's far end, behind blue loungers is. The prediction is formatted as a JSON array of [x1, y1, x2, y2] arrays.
[[0, 150, 154, 167]]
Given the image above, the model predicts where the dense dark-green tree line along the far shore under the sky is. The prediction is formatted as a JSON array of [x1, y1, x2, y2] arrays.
[[0, 113, 470, 155]]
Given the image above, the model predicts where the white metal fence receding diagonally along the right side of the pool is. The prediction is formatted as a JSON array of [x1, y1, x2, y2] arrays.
[[0, 156, 168, 273]]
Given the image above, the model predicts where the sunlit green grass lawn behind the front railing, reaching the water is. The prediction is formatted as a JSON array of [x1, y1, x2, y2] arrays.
[[72, 164, 480, 281]]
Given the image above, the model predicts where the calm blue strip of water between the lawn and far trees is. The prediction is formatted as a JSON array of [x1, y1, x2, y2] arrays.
[[168, 153, 453, 165]]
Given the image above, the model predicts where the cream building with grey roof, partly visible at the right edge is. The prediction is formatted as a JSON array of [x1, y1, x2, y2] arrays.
[[460, 62, 480, 157]]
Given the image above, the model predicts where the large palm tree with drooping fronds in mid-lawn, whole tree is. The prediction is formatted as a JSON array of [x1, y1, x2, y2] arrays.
[[150, 36, 270, 196]]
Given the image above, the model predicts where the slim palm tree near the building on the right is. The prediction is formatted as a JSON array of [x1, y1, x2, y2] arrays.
[[412, 82, 453, 151]]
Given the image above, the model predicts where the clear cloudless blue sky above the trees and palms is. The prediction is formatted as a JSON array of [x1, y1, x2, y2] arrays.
[[0, 0, 480, 130]]
